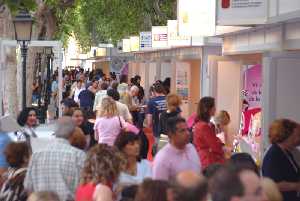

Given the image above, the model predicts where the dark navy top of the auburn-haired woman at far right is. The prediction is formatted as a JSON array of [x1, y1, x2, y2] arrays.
[[262, 144, 300, 201]]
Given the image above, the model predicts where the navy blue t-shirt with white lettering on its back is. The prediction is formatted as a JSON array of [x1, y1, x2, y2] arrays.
[[148, 96, 167, 137]]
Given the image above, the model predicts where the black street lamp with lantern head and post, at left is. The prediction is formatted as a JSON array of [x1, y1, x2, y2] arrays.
[[13, 10, 33, 109]]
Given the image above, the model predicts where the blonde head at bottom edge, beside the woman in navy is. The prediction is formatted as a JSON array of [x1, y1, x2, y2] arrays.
[[261, 178, 283, 201]]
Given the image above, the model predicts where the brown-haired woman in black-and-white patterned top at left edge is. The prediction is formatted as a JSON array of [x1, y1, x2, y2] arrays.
[[0, 142, 30, 201]]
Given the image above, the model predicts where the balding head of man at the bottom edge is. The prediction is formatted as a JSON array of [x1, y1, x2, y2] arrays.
[[171, 171, 208, 201]]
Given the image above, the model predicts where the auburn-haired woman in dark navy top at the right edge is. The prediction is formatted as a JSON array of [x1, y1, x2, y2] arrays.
[[262, 119, 300, 201]]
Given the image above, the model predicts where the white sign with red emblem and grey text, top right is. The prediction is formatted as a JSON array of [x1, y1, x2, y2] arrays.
[[217, 0, 268, 25]]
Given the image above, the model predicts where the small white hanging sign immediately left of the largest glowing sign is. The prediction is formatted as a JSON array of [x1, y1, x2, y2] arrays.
[[152, 26, 168, 48]]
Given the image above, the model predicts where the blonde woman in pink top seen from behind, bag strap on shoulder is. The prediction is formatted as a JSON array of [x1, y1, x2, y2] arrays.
[[94, 97, 126, 146]]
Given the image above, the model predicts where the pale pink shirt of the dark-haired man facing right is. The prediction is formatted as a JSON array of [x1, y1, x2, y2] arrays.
[[153, 143, 201, 180]]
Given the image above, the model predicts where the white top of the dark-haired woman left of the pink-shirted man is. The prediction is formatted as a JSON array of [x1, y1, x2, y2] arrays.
[[119, 160, 152, 186]]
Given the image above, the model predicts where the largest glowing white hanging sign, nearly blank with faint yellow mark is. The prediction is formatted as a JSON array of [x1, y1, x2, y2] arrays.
[[177, 0, 216, 36]]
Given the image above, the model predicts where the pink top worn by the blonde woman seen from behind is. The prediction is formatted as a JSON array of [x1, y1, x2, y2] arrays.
[[94, 116, 126, 146]]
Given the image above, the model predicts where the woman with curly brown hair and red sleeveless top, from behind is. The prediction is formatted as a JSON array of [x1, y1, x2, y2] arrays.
[[75, 144, 126, 201]]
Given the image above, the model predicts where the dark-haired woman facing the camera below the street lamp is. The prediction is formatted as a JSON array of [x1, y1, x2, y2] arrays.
[[17, 107, 38, 141]]
